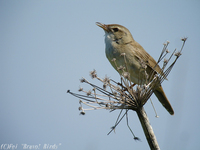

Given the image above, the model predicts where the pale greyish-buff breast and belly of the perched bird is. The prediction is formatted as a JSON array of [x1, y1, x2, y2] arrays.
[[105, 39, 146, 84]]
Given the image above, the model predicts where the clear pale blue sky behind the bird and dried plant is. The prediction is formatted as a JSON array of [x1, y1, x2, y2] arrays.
[[0, 0, 200, 150]]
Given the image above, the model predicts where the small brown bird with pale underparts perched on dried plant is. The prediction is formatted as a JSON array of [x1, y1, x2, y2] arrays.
[[96, 22, 174, 115]]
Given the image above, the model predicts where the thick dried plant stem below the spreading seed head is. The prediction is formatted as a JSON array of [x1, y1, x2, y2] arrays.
[[136, 107, 160, 150]]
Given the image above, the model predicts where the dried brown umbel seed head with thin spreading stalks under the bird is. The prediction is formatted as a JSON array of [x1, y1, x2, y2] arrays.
[[67, 38, 187, 148]]
